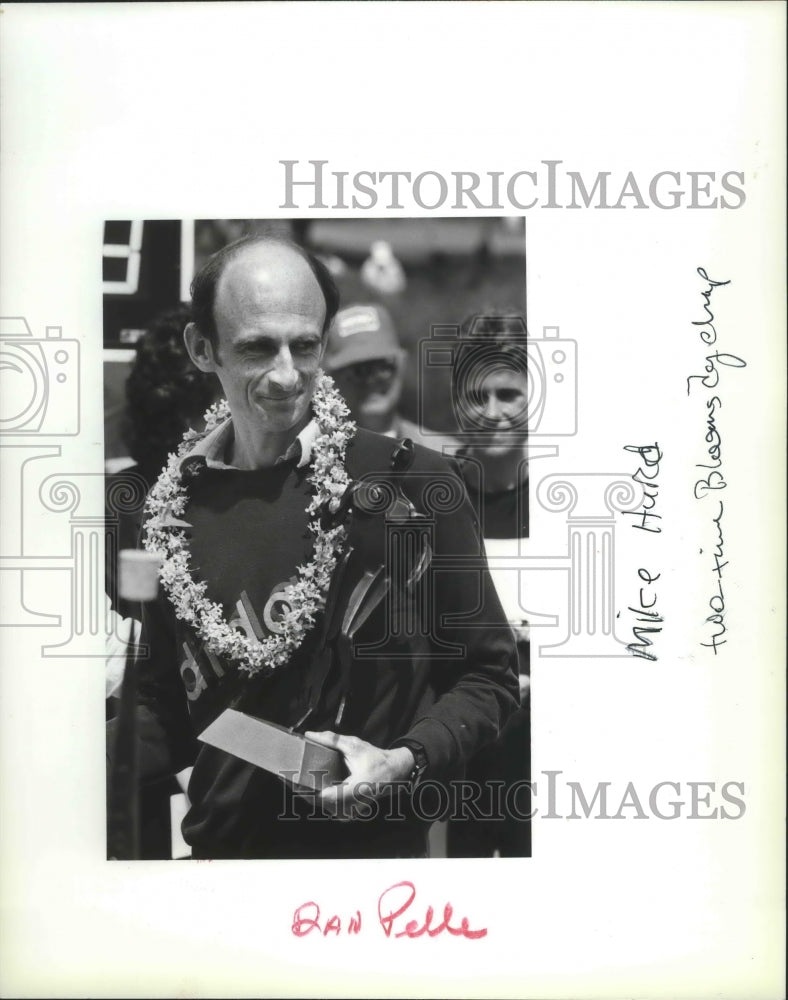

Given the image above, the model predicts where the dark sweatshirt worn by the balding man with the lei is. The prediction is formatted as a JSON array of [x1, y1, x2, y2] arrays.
[[107, 430, 518, 857]]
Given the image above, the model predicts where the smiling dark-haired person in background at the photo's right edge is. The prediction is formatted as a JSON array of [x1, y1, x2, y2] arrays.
[[446, 314, 531, 857]]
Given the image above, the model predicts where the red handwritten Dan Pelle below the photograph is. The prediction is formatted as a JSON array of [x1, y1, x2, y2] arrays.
[[290, 882, 487, 941]]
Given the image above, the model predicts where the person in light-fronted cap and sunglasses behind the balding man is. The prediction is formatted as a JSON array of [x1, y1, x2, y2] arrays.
[[323, 303, 457, 452]]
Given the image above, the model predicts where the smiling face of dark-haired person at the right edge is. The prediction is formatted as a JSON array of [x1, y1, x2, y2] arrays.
[[463, 368, 528, 455]]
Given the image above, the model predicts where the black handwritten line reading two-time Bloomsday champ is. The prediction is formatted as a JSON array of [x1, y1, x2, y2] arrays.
[[687, 267, 747, 656]]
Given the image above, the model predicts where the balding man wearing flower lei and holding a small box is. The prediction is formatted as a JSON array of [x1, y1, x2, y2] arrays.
[[110, 239, 518, 858]]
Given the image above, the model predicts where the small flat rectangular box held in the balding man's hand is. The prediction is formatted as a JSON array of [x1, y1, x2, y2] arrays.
[[198, 708, 348, 791]]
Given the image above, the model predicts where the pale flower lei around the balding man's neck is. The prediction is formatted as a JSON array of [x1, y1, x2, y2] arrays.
[[144, 371, 356, 676]]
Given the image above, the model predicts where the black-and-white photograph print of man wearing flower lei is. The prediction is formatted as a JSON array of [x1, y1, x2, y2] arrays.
[[103, 217, 532, 860]]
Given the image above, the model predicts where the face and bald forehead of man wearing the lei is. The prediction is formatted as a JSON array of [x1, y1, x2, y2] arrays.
[[208, 245, 325, 439]]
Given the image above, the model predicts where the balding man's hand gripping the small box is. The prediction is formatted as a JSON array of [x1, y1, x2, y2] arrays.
[[304, 732, 415, 821]]
